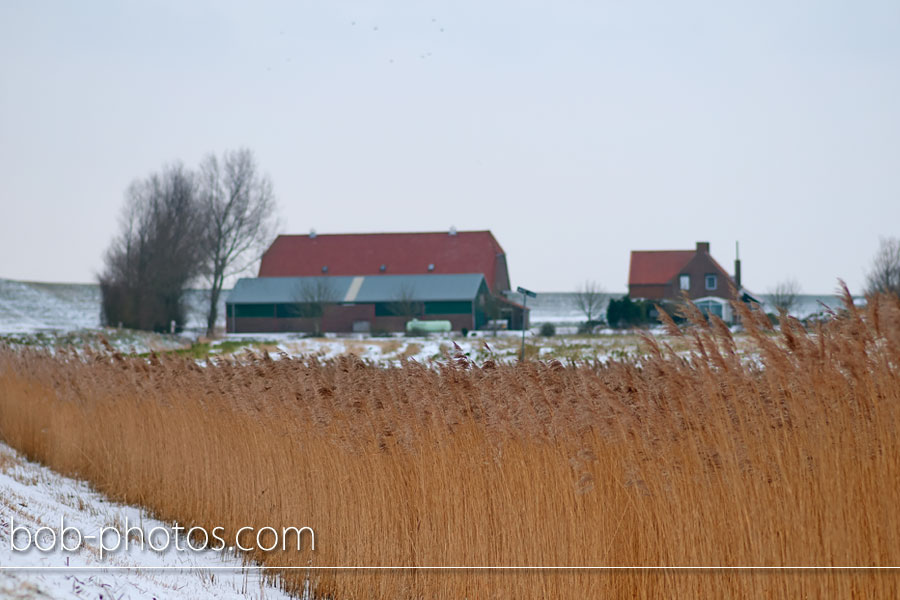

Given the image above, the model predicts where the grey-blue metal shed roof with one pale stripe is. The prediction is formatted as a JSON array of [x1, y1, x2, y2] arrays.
[[225, 273, 487, 304]]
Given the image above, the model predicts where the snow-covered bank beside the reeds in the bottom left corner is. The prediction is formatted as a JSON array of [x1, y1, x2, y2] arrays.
[[0, 443, 298, 600]]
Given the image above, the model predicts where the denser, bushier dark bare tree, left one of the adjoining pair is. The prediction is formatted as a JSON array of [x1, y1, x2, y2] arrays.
[[99, 164, 202, 331]]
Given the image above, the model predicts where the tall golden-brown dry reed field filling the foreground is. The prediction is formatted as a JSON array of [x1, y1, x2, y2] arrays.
[[0, 296, 900, 600]]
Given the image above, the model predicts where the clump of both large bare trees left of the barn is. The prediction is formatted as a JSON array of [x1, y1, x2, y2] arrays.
[[99, 148, 277, 335]]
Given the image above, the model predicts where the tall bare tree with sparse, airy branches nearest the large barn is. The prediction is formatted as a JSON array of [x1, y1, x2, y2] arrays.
[[199, 148, 277, 335]]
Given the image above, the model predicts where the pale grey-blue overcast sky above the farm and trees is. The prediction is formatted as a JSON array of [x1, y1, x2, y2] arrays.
[[0, 0, 900, 293]]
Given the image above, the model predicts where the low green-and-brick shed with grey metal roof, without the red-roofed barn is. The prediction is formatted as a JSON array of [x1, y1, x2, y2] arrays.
[[225, 273, 506, 333]]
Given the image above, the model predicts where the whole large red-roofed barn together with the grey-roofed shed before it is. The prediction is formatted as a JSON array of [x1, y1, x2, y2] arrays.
[[239, 229, 528, 331]]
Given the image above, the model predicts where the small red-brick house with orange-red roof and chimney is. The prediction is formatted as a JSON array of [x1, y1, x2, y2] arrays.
[[628, 242, 758, 322]]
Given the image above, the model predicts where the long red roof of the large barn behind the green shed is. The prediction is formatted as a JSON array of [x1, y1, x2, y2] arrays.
[[259, 231, 509, 290]]
